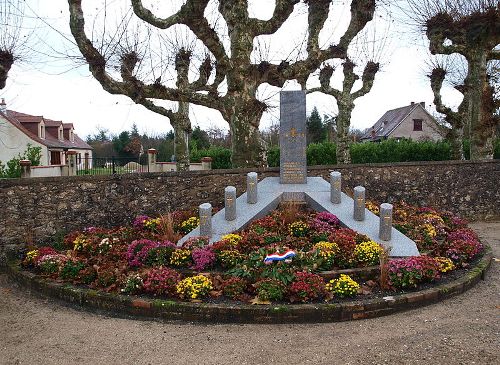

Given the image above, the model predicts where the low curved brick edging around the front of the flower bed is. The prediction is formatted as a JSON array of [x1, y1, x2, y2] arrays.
[[5, 246, 493, 323]]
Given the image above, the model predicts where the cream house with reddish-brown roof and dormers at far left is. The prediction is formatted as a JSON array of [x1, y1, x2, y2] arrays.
[[0, 99, 92, 166]]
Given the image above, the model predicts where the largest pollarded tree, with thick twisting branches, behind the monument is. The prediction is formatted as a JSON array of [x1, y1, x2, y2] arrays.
[[68, 0, 375, 166]]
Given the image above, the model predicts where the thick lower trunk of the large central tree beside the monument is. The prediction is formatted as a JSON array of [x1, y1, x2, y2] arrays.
[[229, 108, 267, 167]]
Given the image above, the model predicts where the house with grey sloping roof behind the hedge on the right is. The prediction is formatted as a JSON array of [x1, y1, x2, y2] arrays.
[[361, 102, 443, 142]]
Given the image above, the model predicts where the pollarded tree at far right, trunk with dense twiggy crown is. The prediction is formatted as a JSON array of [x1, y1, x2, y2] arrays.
[[408, 0, 500, 160]]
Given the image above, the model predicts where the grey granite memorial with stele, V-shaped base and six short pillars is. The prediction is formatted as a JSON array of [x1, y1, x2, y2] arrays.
[[178, 91, 419, 257]]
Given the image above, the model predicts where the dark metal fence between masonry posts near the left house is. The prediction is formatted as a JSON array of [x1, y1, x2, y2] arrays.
[[76, 157, 149, 175]]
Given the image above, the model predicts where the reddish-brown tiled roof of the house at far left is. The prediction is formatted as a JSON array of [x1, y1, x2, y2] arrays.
[[0, 110, 93, 150]]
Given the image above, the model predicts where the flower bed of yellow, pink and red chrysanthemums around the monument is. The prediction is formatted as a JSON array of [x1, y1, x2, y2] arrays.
[[18, 203, 483, 304]]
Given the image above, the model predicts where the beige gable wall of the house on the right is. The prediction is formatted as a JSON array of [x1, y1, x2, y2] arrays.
[[389, 106, 443, 141]]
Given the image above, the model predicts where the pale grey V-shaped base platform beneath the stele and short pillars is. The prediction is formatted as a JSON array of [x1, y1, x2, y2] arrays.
[[179, 177, 419, 257]]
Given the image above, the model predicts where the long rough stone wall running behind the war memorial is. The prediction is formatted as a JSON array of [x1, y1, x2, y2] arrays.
[[0, 160, 500, 256]]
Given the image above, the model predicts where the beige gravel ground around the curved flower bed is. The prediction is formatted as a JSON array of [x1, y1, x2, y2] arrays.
[[0, 222, 500, 365]]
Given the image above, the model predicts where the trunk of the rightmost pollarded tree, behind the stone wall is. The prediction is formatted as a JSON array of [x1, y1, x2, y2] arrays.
[[467, 52, 496, 160]]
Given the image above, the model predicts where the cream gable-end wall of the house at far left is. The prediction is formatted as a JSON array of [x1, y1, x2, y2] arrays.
[[0, 116, 49, 165]]
